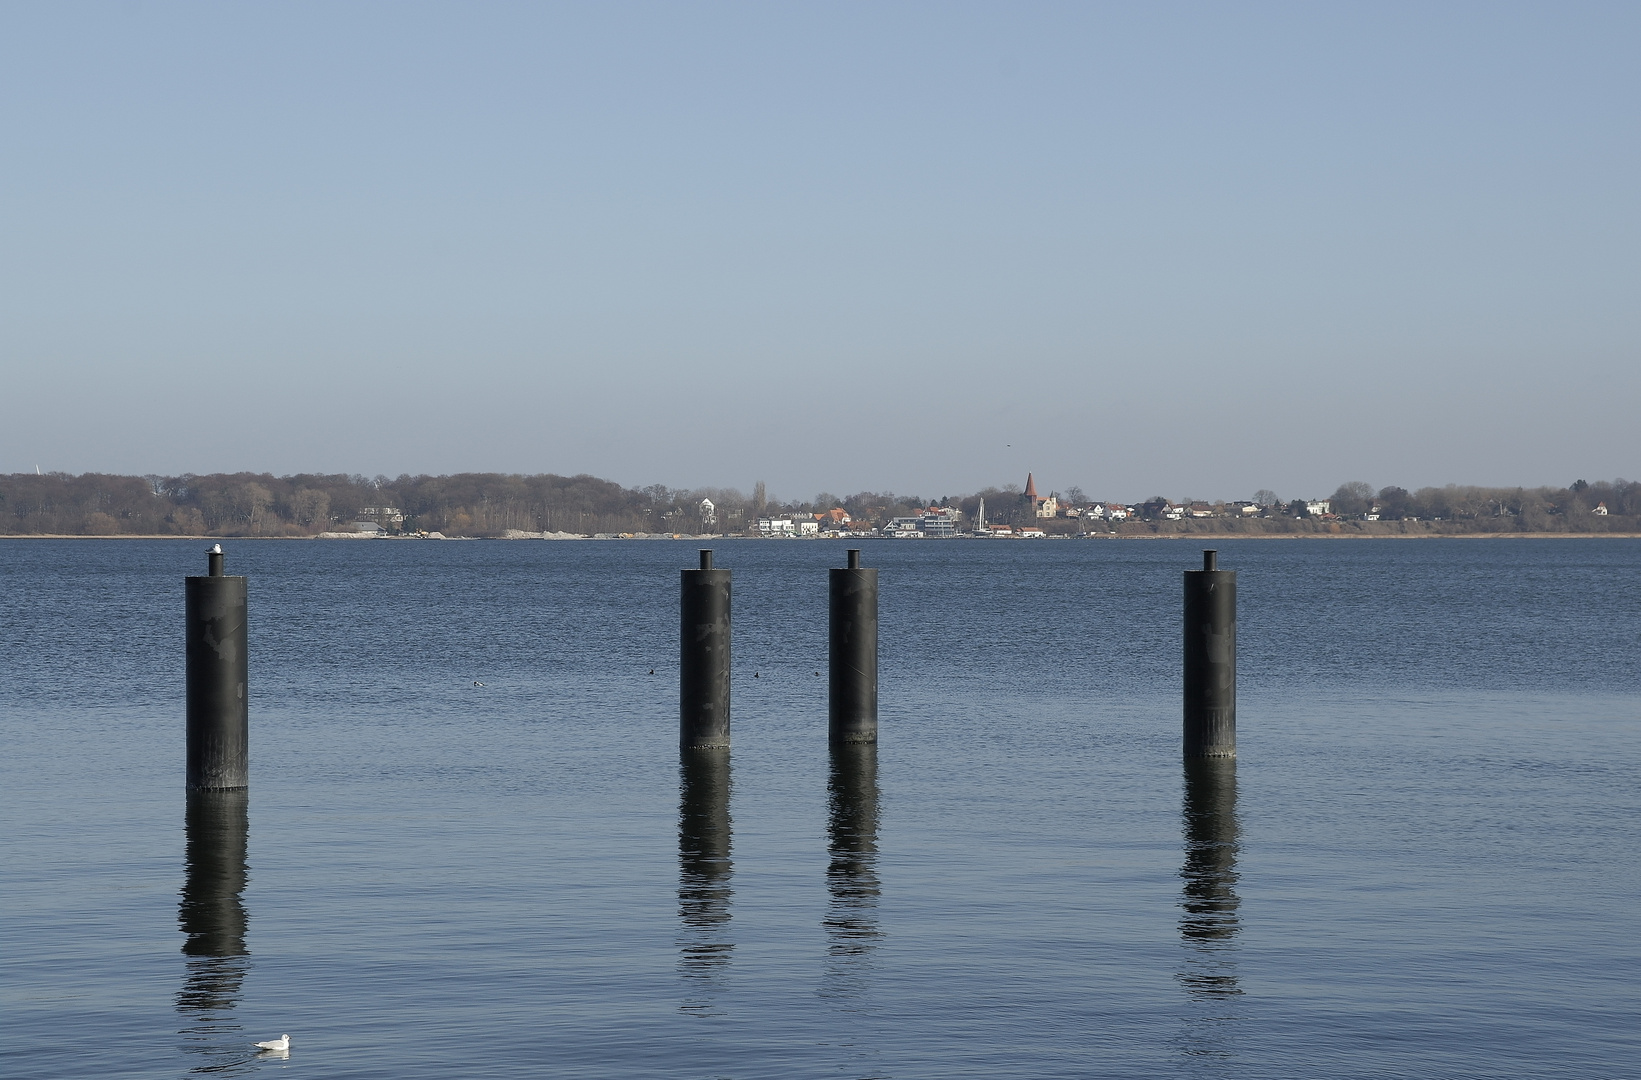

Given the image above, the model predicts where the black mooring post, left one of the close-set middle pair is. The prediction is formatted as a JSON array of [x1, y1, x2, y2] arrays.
[[678, 550, 729, 750]]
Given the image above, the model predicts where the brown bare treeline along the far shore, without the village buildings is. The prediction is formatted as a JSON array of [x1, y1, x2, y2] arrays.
[[0, 473, 1641, 537]]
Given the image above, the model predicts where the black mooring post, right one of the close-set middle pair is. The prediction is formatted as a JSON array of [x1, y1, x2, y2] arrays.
[[827, 548, 878, 745]]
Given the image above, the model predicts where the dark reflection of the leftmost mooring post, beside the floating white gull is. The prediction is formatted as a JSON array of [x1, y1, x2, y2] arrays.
[[177, 789, 249, 1072]]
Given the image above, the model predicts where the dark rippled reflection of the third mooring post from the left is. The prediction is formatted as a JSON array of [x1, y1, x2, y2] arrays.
[[822, 742, 883, 995]]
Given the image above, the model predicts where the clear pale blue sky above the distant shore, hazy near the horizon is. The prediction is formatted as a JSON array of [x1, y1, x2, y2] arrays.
[[0, 2, 1641, 499]]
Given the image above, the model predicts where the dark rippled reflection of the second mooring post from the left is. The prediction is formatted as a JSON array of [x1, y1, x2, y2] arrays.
[[678, 748, 735, 1014]]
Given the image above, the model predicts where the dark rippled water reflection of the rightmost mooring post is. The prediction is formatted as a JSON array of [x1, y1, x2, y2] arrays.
[[1180, 758, 1242, 1055]]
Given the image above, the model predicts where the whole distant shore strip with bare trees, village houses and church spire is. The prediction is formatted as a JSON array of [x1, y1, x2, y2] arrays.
[[9, 473, 1641, 542]]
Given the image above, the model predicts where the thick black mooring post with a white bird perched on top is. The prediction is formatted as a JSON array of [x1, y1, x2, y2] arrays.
[[184, 545, 249, 791]]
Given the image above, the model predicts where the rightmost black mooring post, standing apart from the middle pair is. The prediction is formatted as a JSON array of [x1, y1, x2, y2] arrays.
[[1185, 551, 1236, 758]]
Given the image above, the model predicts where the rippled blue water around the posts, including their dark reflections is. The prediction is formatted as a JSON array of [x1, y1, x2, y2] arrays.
[[0, 540, 1641, 1077]]
